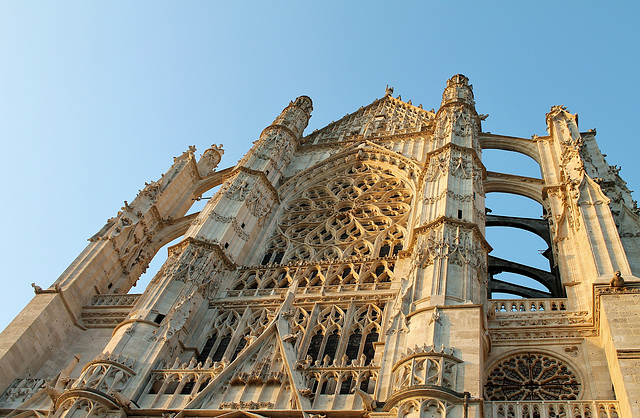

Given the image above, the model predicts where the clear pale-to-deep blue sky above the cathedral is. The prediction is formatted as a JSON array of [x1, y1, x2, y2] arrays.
[[0, 1, 640, 329]]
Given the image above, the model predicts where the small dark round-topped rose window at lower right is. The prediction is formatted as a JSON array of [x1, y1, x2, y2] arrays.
[[485, 353, 580, 401]]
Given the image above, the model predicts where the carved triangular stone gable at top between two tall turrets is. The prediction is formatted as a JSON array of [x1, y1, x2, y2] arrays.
[[302, 95, 435, 145]]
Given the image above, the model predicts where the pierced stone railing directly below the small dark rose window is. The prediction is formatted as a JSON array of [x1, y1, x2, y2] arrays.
[[484, 401, 620, 418]]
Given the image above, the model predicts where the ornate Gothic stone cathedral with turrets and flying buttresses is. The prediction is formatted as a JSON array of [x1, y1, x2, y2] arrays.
[[0, 74, 640, 418]]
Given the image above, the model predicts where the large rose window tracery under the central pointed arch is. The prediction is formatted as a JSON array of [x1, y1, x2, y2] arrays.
[[262, 161, 413, 264]]
